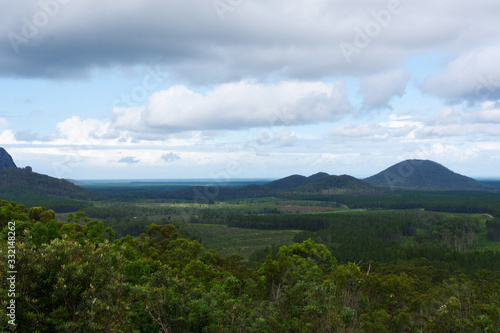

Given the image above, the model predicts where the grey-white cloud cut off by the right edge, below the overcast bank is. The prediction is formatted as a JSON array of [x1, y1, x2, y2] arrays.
[[422, 43, 500, 104]]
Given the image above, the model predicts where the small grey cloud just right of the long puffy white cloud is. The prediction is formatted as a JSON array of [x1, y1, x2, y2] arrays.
[[358, 70, 410, 108]]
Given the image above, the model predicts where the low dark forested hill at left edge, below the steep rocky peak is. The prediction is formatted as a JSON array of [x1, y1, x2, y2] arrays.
[[0, 167, 97, 200]]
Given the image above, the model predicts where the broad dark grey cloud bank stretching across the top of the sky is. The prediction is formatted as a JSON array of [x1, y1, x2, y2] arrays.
[[0, 0, 500, 84]]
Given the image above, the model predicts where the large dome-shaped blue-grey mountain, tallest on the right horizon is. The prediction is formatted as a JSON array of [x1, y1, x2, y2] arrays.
[[364, 160, 489, 191]]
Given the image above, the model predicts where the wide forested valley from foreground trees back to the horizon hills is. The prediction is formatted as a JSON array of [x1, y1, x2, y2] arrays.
[[0, 151, 500, 333]]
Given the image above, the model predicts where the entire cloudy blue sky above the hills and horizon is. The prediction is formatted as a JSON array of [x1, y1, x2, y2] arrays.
[[0, 0, 500, 181]]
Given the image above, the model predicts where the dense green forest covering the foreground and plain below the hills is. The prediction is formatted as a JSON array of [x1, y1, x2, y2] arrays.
[[0, 197, 500, 332]]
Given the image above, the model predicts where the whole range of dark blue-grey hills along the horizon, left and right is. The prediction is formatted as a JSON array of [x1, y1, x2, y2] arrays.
[[0, 148, 494, 209]]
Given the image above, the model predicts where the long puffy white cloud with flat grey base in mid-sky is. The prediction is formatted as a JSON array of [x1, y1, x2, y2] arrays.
[[112, 81, 352, 138]]
